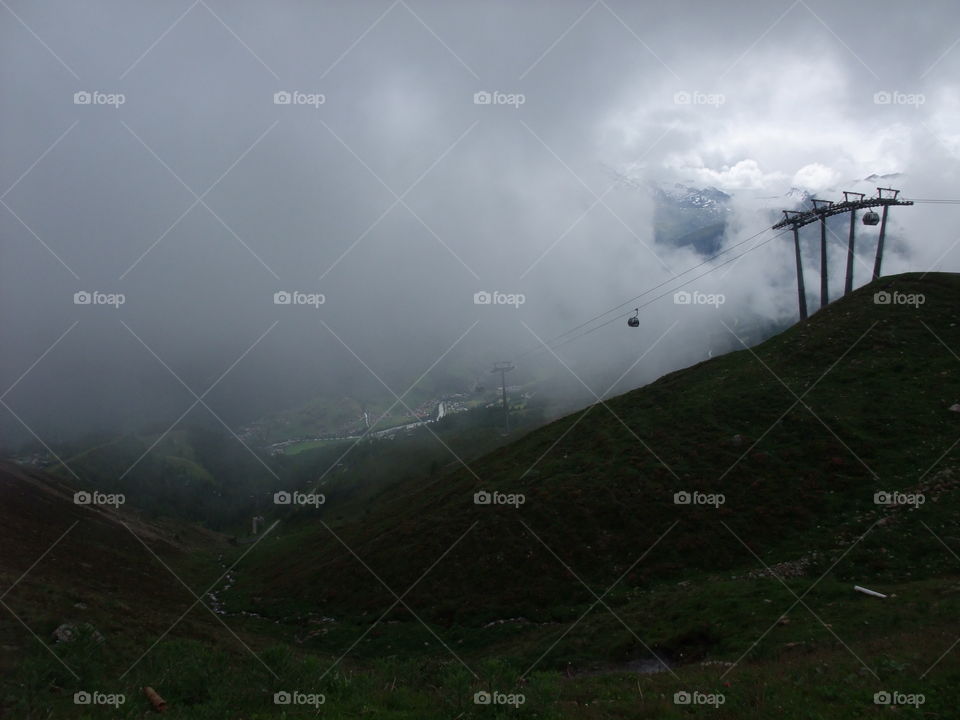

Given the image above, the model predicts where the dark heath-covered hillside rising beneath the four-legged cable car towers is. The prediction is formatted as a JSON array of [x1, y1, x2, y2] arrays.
[[234, 273, 960, 623]]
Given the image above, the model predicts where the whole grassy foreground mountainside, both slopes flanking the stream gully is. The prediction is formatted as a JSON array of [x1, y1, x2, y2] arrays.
[[7, 274, 960, 720]]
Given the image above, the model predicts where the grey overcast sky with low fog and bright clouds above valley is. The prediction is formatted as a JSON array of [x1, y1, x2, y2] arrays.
[[0, 0, 960, 438]]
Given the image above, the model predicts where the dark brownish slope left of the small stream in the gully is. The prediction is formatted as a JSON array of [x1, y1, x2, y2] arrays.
[[0, 463, 226, 680]]
